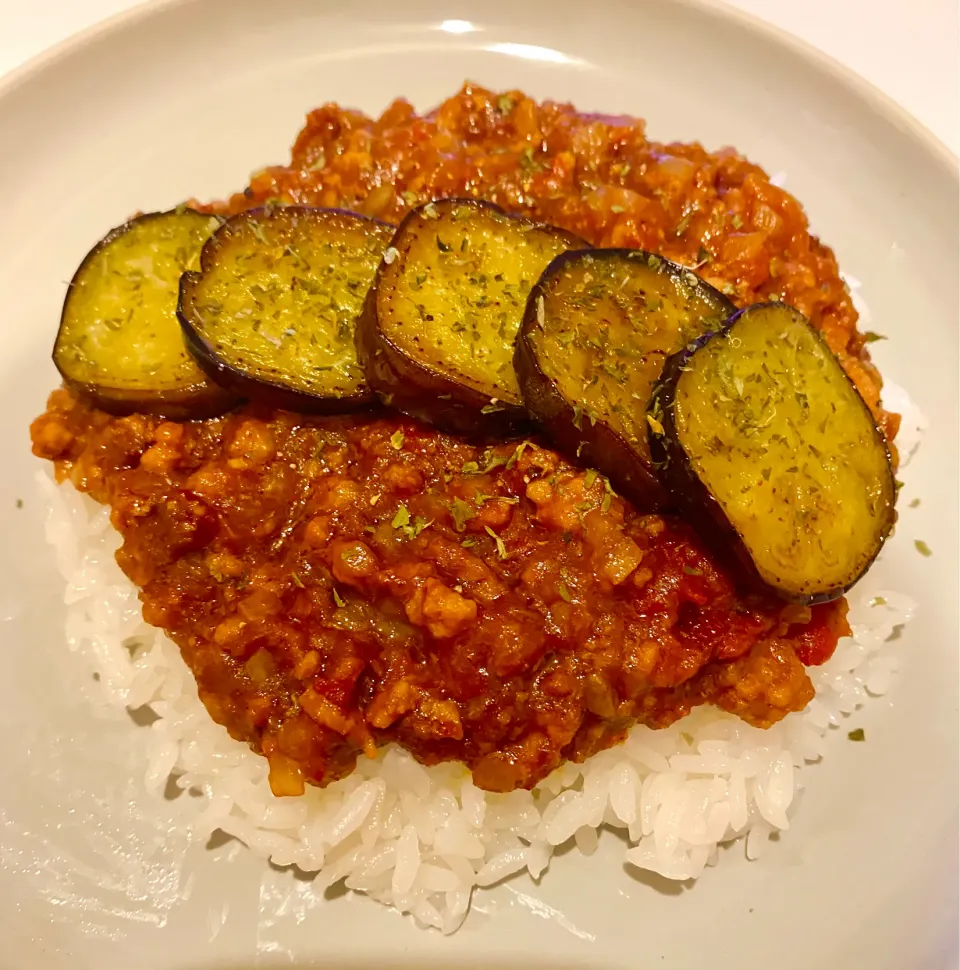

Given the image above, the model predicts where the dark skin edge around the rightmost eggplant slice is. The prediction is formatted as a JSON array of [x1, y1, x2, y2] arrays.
[[647, 300, 896, 606]]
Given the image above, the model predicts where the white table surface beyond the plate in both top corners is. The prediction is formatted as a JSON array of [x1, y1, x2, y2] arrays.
[[0, 0, 960, 153]]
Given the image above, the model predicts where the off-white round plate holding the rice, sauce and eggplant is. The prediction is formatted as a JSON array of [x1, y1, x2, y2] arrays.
[[0, 0, 960, 970]]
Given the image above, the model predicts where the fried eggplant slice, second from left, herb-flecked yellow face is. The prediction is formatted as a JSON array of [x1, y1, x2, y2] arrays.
[[178, 205, 393, 413]]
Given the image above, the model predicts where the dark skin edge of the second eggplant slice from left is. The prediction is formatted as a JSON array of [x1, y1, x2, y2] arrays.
[[177, 205, 393, 415]]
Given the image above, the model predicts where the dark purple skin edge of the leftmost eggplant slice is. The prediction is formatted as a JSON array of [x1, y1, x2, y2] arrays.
[[50, 206, 240, 421]]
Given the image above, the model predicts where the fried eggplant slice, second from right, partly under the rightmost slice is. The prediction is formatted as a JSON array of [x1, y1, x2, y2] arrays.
[[515, 249, 735, 511]]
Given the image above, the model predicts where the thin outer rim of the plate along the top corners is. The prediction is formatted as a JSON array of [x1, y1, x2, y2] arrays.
[[0, 0, 960, 174]]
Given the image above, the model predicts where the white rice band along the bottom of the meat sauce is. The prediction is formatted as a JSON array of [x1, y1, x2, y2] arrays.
[[38, 471, 915, 933]]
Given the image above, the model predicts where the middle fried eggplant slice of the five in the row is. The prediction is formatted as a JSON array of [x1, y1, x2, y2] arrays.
[[357, 199, 587, 437]]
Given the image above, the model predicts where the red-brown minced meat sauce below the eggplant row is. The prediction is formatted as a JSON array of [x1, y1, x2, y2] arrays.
[[34, 391, 848, 794]]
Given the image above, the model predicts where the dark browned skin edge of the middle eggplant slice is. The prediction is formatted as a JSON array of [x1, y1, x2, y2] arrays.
[[356, 197, 589, 441]]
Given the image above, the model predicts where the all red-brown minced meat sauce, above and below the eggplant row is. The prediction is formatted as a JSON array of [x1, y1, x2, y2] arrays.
[[32, 87, 876, 794]]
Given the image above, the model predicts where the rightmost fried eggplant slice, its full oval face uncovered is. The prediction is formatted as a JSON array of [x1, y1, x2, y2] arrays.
[[648, 303, 896, 604]]
